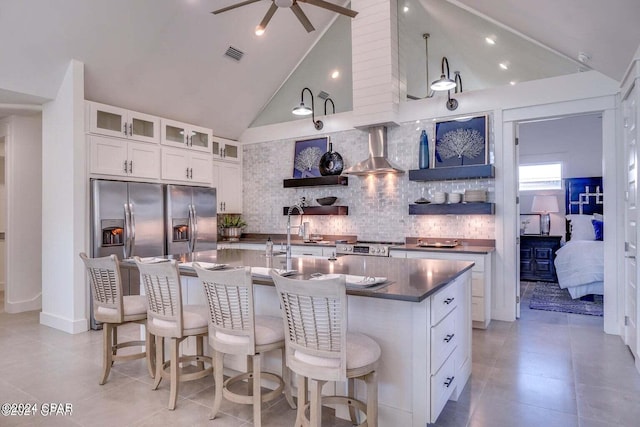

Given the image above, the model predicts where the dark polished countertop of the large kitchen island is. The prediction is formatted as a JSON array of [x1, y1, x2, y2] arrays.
[[122, 249, 474, 302]]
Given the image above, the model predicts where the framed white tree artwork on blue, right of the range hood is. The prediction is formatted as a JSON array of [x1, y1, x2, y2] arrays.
[[434, 115, 489, 168]]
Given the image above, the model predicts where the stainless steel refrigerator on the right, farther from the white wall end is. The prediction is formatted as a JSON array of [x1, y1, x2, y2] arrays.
[[165, 185, 218, 255]]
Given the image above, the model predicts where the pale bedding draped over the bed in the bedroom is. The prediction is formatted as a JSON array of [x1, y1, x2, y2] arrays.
[[555, 240, 604, 298]]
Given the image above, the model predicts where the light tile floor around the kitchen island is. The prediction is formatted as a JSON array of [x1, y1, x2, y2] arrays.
[[0, 289, 640, 427]]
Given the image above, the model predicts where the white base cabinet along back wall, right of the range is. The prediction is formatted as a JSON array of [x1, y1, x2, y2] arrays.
[[404, 250, 493, 329]]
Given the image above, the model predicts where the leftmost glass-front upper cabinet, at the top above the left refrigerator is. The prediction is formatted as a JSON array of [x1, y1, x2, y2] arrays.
[[87, 102, 160, 143]]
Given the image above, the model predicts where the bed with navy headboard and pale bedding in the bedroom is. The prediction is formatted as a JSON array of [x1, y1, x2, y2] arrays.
[[554, 177, 604, 299]]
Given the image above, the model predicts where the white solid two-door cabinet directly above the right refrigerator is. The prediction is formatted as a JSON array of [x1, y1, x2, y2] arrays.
[[162, 147, 212, 185]]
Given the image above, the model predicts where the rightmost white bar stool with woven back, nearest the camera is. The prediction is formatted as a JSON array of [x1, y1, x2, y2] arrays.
[[271, 271, 381, 427]]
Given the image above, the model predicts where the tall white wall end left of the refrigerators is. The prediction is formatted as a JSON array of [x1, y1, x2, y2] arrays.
[[40, 60, 89, 333]]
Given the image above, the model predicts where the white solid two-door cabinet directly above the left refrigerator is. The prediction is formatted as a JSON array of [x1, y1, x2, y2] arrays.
[[87, 135, 160, 179]]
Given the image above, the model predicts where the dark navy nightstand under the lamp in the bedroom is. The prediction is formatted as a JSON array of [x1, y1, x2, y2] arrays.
[[520, 235, 562, 282]]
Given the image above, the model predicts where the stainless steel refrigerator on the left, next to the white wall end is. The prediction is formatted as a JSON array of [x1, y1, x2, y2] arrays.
[[91, 179, 166, 316]]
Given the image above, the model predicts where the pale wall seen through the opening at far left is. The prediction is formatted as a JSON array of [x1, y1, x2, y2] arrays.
[[4, 114, 42, 313]]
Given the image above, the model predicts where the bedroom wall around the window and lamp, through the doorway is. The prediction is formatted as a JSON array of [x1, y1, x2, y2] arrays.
[[519, 114, 602, 236]]
